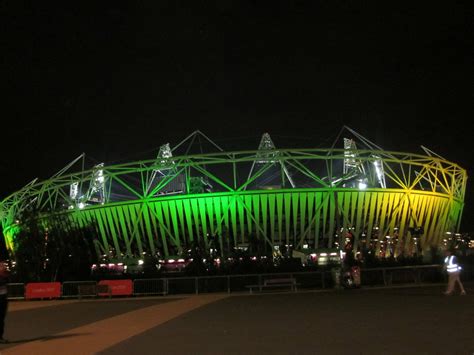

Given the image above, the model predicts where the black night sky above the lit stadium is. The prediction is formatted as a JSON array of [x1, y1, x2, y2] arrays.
[[0, 0, 474, 230]]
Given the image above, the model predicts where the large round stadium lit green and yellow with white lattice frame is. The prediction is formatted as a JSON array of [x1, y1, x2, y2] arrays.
[[1, 127, 467, 260]]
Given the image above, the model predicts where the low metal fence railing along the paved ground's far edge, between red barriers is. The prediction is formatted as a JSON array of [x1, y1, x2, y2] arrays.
[[8, 265, 452, 299]]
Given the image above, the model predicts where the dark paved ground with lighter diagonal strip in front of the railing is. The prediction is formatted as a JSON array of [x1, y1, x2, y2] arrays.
[[0, 284, 474, 355]]
